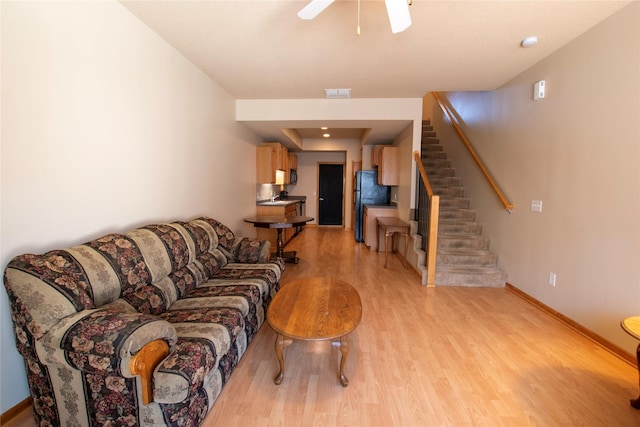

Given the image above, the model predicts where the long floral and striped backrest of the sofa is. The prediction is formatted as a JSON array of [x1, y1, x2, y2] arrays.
[[5, 217, 235, 339]]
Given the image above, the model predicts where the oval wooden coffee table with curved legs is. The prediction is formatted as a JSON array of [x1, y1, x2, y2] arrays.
[[267, 277, 362, 387]]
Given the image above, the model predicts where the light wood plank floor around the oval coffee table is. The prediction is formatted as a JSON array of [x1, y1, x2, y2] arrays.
[[11, 227, 640, 427]]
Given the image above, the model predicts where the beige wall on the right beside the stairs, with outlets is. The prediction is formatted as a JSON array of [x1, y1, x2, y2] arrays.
[[426, 2, 640, 353]]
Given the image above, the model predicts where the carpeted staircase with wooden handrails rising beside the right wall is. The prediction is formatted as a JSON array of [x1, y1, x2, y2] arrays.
[[421, 121, 507, 287]]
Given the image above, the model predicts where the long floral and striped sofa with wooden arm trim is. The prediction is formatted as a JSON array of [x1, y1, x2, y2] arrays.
[[5, 218, 284, 426]]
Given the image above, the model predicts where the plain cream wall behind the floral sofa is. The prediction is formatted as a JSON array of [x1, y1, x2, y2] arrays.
[[0, 1, 260, 413]]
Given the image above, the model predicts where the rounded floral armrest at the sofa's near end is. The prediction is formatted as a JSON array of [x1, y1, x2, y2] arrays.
[[36, 309, 178, 377]]
